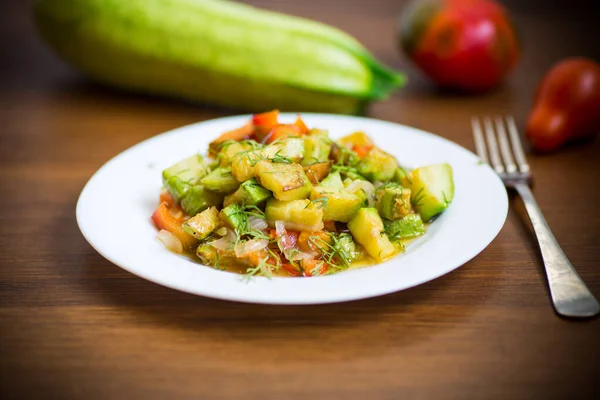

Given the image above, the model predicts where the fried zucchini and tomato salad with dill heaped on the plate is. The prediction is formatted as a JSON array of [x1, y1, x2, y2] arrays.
[[152, 111, 454, 277]]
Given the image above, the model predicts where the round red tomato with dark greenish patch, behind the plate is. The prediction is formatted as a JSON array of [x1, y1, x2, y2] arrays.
[[400, 0, 519, 92]]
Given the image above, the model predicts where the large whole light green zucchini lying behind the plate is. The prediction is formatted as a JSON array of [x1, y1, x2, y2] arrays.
[[34, 0, 404, 114]]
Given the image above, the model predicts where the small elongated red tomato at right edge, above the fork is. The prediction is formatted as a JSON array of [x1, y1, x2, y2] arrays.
[[526, 58, 600, 152]]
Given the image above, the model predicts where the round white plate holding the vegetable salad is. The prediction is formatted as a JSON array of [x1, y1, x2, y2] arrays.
[[77, 114, 508, 304]]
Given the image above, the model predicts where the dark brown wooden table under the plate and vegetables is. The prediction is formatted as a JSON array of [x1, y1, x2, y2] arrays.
[[0, 0, 600, 400]]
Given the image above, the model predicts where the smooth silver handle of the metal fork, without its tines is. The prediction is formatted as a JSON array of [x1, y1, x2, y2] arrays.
[[514, 183, 600, 318]]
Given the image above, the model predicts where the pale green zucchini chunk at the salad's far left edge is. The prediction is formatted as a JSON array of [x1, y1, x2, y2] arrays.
[[162, 154, 209, 202]]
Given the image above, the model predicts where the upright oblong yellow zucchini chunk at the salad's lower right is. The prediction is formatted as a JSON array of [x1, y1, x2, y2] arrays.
[[348, 208, 396, 262]]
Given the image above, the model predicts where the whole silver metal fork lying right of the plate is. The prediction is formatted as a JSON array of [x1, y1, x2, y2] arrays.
[[471, 116, 600, 318]]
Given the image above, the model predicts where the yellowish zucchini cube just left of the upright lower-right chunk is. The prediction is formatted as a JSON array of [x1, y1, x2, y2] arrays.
[[310, 186, 364, 222]]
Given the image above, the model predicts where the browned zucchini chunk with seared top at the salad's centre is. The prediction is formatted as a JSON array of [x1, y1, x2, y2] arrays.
[[255, 160, 312, 201]]
